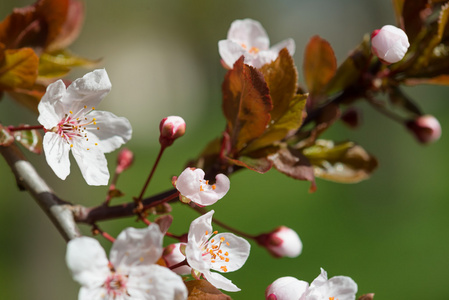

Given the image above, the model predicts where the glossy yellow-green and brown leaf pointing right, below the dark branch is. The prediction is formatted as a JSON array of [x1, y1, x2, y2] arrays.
[[302, 140, 377, 183]]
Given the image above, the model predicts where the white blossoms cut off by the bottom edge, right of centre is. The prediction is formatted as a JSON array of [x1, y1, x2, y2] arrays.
[[265, 269, 357, 300]]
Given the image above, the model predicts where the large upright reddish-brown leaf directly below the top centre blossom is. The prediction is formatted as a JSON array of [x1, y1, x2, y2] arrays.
[[222, 56, 273, 153]]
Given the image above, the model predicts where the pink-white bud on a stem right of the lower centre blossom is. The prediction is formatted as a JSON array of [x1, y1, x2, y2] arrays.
[[256, 226, 302, 257]]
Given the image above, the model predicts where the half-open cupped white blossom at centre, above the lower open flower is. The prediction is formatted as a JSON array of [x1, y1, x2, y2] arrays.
[[176, 168, 231, 206]]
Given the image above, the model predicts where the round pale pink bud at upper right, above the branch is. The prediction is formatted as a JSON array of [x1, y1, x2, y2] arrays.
[[371, 25, 410, 64]]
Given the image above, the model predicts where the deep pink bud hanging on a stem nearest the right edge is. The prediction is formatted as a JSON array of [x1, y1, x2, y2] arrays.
[[405, 115, 441, 144]]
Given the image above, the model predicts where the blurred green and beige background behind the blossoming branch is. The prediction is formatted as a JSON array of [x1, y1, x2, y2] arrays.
[[0, 0, 449, 300]]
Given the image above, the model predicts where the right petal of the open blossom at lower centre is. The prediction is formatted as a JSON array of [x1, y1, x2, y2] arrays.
[[211, 232, 251, 272]]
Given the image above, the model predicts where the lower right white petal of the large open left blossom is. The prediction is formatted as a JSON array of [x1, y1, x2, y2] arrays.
[[72, 135, 109, 185]]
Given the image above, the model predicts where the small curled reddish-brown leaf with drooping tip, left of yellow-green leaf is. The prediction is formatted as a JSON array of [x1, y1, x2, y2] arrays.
[[269, 147, 316, 192]]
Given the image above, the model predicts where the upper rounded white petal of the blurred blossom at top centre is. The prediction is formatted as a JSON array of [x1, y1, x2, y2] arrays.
[[228, 19, 270, 50]]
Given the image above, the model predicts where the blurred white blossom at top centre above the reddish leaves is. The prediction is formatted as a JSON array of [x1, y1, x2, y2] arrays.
[[218, 19, 295, 69]]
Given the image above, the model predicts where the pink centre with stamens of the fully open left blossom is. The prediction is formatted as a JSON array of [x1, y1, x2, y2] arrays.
[[50, 106, 100, 150]]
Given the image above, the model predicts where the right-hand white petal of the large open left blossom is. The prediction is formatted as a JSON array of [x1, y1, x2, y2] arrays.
[[87, 110, 132, 153]]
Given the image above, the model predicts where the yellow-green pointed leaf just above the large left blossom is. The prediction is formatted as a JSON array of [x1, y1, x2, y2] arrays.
[[39, 50, 99, 78]]
